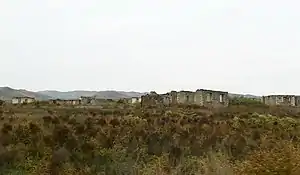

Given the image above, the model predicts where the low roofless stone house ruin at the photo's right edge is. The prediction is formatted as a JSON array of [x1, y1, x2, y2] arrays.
[[262, 95, 300, 106]]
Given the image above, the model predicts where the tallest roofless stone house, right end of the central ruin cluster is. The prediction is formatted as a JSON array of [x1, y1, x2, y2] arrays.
[[194, 89, 229, 107]]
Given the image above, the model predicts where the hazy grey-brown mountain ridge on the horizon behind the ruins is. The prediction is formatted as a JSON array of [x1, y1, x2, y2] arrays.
[[0, 87, 260, 100]]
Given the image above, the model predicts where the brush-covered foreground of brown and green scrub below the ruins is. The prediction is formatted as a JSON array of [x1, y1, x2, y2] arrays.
[[0, 104, 300, 175]]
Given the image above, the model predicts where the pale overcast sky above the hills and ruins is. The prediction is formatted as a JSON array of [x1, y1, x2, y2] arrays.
[[0, 0, 300, 95]]
